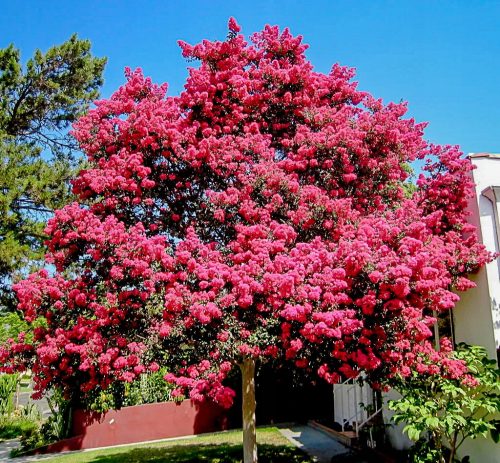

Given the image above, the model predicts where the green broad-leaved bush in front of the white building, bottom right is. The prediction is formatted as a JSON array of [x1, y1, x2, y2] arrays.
[[389, 344, 500, 463]]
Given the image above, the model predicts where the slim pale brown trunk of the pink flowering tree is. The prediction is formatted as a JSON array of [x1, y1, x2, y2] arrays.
[[240, 358, 257, 463]]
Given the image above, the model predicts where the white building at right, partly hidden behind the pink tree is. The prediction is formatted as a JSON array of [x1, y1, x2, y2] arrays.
[[334, 153, 500, 463]]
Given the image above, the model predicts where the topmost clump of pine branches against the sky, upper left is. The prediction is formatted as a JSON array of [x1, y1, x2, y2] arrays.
[[0, 35, 106, 155]]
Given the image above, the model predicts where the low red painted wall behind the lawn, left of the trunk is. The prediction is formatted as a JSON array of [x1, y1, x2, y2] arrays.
[[43, 400, 228, 453]]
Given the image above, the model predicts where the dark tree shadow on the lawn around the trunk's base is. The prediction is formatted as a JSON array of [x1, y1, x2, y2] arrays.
[[88, 444, 312, 463]]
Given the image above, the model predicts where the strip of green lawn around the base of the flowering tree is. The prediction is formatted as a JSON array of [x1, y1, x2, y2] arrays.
[[41, 427, 313, 463]]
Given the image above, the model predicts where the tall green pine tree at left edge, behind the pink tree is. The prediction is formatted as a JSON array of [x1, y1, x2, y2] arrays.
[[0, 35, 106, 310]]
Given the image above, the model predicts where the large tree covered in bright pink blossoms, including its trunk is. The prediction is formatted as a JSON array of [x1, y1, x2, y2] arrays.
[[0, 19, 490, 462]]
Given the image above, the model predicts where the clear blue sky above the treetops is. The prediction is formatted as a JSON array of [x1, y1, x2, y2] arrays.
[[0, 0, 500, 156]]
